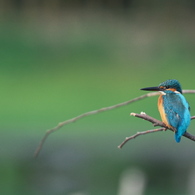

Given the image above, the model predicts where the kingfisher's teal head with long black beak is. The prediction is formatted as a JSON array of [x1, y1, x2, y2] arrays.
[[141, 79, 182, 93]]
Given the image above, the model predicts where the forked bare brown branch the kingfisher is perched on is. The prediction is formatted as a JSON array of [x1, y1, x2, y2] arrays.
[[118, 113, 195, 148]]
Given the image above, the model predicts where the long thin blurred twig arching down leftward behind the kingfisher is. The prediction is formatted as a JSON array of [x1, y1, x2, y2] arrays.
[[34, 90, 195, 157]]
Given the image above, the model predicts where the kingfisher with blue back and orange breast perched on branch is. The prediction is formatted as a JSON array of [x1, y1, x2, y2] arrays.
[[141, 79, 191, 143]]
